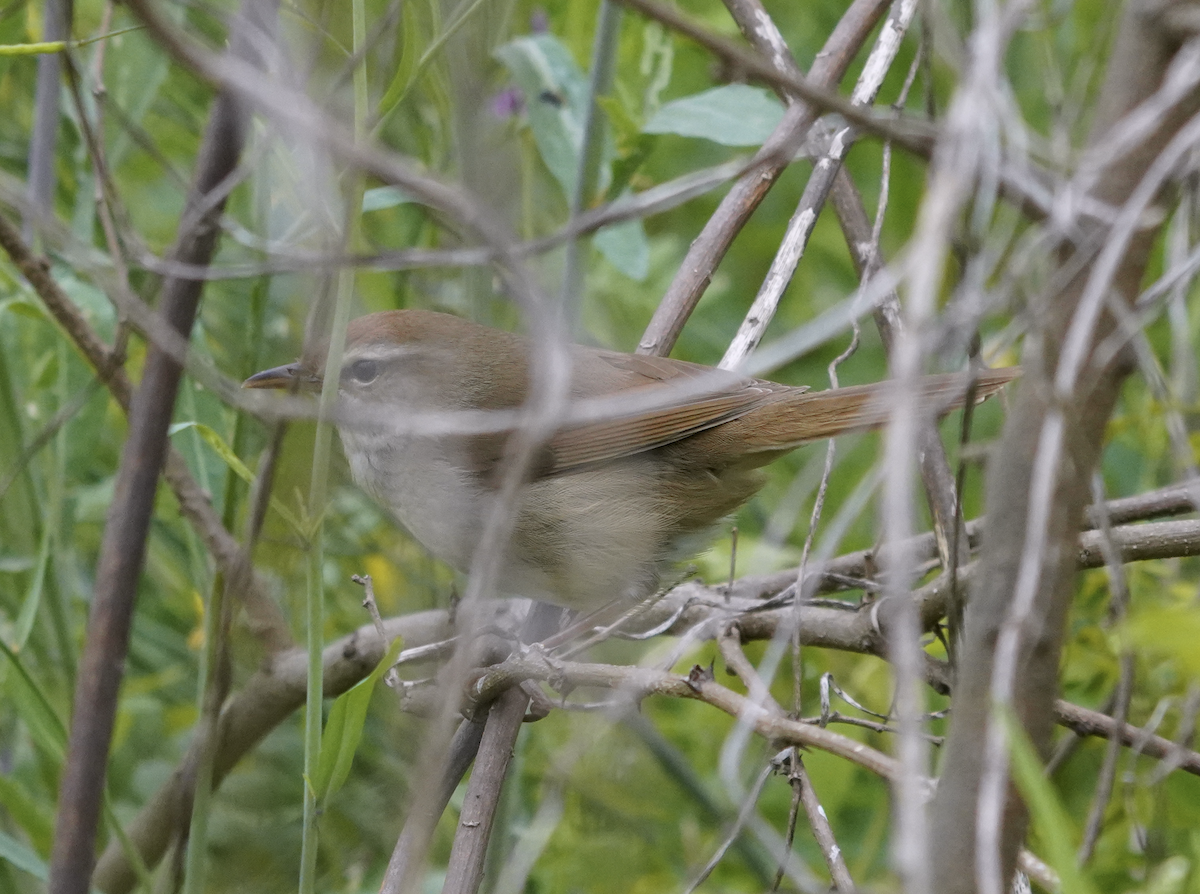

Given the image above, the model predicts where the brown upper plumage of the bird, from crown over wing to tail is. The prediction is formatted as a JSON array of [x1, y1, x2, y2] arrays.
[[347, 311, 1020, 476]]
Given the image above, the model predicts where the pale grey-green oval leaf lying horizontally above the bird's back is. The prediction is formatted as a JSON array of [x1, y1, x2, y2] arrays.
[[643, 84, 784, 146]]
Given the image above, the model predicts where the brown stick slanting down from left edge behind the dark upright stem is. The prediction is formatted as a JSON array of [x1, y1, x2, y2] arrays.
[[0, 217, 292, 654]]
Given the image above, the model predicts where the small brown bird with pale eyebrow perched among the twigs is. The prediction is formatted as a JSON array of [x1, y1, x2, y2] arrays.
[[244, 310, 1020, 611]]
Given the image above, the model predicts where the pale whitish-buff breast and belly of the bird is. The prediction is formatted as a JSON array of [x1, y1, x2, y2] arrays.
[[342, 432, 727, 610]]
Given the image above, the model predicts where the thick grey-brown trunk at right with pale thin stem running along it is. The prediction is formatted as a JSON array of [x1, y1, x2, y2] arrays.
[[940, 8, 1200, 894]]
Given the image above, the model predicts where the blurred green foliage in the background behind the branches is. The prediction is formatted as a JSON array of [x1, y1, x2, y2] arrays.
[[0, 0, 1200, 894]]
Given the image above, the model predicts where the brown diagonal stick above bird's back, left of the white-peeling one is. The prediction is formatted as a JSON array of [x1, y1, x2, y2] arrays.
[[629, 0, 886, 355]]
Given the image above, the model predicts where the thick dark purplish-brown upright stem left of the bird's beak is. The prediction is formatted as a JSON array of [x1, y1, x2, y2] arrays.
[[48, 0, 266, 894]]
